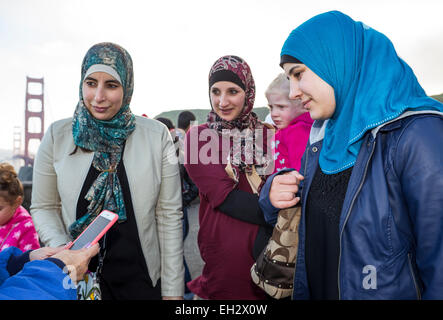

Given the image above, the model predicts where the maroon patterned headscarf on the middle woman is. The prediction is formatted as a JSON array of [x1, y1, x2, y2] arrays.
[[207, 55, 273, 189]]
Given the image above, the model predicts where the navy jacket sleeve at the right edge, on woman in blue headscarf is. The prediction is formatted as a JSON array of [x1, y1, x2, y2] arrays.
[[395, 117, 443, 300]]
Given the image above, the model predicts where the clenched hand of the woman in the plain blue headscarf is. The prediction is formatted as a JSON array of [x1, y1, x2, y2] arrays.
[[269, 171, 305, 209]]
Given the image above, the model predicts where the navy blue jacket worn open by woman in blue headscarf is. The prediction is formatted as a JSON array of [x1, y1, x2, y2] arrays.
[[259, 112, 443, 299]]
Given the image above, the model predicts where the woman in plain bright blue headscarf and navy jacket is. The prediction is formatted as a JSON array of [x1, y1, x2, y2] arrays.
[[260, 11, 443, 299]]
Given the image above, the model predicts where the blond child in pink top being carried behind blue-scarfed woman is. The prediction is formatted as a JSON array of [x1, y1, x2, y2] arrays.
[[265, 73, 314, 173]]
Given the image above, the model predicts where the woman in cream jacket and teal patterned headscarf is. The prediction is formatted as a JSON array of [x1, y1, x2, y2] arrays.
[[31, 43, 184, 299]]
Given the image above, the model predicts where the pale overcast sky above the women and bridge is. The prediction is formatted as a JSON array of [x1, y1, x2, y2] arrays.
[[0, 0, 443, 149]]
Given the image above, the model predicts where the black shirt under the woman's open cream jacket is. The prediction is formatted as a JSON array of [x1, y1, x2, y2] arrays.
[[77, 151, 161, 300]]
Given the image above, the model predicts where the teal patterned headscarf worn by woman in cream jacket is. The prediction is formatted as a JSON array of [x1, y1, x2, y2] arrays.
[[69, 43, 135, 238]]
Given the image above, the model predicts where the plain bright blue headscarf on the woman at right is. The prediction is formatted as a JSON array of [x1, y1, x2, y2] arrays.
[[281, 11, 443, 174]]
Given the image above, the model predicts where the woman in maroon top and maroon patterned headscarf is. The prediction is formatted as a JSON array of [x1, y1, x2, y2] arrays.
[[185, 56, 273, 300]]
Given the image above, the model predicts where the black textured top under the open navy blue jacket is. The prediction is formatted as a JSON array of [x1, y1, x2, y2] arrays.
[[305, 166, 352, 300]]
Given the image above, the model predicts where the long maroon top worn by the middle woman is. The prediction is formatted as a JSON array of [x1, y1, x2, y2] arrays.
[[185, 124, 265, 300]]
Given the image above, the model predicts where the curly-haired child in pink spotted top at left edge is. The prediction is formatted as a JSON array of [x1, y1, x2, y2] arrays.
[[0, 162, 40, 251]]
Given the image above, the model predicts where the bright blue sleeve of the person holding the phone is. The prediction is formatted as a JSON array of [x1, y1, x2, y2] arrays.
[[0, 248, 77, 300]]
